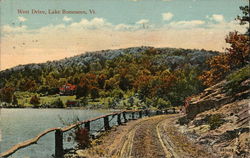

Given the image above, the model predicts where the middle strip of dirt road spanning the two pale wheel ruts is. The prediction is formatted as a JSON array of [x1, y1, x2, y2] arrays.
[[118, 116, 172, 158]]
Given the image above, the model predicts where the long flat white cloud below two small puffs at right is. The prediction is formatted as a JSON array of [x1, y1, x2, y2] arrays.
[[168, 20, 205, 28]]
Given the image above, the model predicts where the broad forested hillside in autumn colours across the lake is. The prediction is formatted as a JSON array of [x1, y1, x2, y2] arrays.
[[0, 47, 219, 108]]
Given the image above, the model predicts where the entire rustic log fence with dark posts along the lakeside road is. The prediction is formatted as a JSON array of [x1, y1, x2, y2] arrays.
[[0, 108, 176, 158]]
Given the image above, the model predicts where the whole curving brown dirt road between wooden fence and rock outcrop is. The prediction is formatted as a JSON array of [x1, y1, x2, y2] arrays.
[[67, 115, 212, 158]]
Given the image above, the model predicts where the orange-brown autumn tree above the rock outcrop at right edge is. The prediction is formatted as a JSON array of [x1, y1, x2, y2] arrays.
[[199, 6, 250, 86]]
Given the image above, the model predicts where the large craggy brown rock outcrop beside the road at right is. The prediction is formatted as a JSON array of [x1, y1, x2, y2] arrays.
[[181, 74, 250, 158]]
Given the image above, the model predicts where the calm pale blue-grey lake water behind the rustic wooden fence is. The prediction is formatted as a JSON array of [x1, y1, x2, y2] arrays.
[[0, 109, 116, 158]]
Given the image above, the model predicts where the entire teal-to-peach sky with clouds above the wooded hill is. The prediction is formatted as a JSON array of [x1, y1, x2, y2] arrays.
[[0, 0, 249, 70]]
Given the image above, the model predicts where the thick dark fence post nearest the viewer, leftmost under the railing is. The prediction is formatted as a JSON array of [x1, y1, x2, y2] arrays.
[[55, 129, 63, 158]]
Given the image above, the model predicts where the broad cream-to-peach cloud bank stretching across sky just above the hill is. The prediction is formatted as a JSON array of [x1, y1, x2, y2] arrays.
[[0, 18, 245, 69]]
